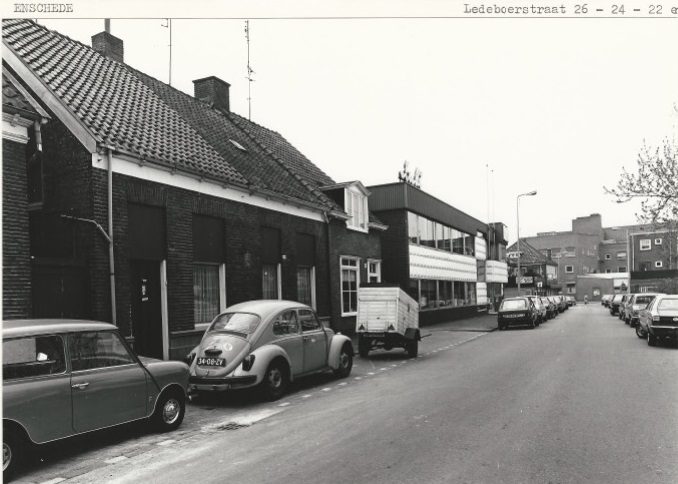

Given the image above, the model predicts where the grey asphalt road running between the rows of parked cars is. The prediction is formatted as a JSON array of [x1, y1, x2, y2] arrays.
[[14, 304, 678, 484]]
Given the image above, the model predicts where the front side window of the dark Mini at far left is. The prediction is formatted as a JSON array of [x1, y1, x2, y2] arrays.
[[68, 331, 135, 371]]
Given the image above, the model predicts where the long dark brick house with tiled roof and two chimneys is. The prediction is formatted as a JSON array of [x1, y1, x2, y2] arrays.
[[3, 19, 386, 359]]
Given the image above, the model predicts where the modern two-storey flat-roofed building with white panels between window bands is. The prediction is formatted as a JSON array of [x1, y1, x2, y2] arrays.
[[368, 182, 507, 325]]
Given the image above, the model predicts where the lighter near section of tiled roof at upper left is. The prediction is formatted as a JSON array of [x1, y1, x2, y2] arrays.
[[2, 19, 248, 185]]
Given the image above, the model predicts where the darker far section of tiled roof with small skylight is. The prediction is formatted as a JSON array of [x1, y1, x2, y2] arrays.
[[129, 68, 340, 210]]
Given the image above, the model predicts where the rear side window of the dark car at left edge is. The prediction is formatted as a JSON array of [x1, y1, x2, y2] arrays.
[[2, 335, 66, 380]]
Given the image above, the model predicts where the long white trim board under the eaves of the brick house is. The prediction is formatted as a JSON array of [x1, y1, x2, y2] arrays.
[[92, 153, 325, 222]]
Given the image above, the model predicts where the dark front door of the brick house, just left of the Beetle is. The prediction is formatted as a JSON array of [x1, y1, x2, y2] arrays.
[[131, 260, 163, 360]]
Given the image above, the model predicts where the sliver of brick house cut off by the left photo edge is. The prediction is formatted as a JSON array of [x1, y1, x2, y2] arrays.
[[2, 66, 49, 319]]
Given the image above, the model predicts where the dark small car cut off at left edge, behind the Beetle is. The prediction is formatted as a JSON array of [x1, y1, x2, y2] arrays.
[[2, 319, 188, 480]]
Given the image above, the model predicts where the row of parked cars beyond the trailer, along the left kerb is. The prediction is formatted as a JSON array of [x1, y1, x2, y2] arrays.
[[497, 296, 576, 330]]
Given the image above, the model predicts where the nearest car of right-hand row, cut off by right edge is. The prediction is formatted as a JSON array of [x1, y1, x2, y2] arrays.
[[636, 294, 678, 346]]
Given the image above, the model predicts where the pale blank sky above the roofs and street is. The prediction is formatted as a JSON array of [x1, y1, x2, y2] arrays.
[[3, 0, 678, 241]]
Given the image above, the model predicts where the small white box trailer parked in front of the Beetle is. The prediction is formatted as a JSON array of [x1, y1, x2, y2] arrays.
[[356, 284, 421, 358]]
